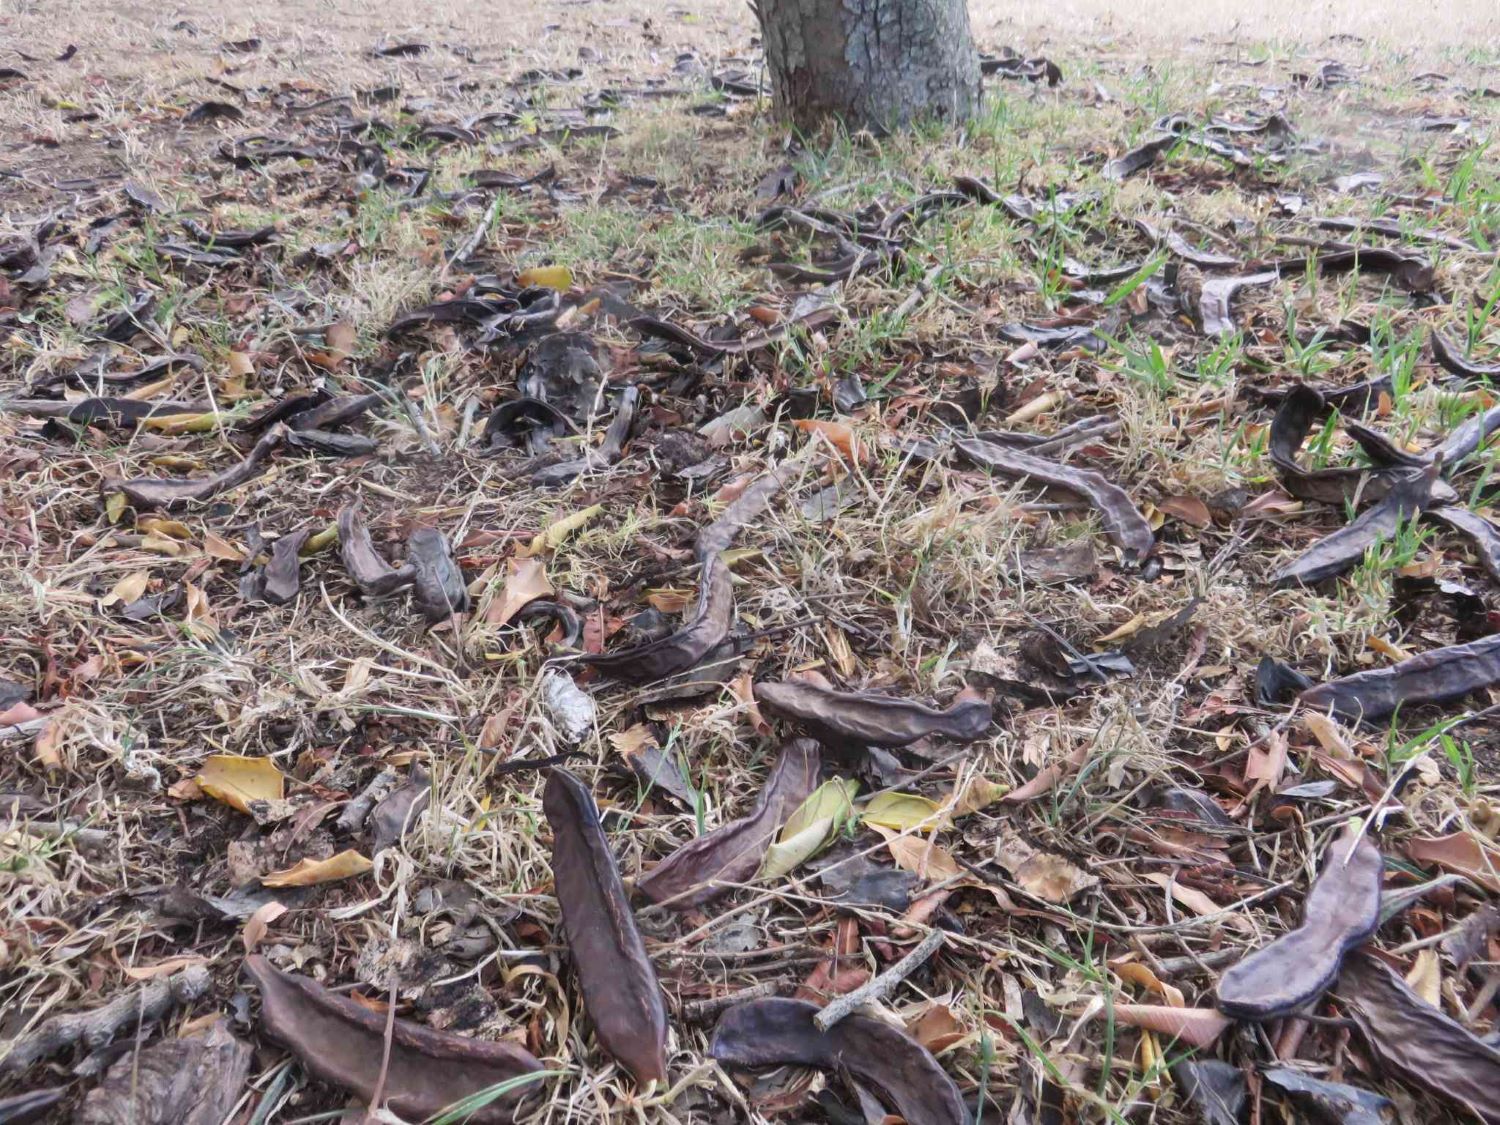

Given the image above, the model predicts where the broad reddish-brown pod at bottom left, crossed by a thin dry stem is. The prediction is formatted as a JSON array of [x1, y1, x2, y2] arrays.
[[245, 954, 542, 1122]]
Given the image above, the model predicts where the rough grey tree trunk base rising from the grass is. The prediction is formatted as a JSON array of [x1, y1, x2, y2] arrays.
[[759, 0, 980, 132]]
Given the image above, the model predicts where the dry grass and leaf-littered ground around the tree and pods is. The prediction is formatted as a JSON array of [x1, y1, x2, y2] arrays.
[[0, 3, 1500, 1122]]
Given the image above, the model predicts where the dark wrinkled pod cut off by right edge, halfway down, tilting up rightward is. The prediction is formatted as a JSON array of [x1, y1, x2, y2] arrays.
[[1298, 633, 1500, 720]]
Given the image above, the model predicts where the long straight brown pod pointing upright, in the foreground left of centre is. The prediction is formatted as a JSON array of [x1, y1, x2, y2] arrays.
[[542, 770, 666, 1085]]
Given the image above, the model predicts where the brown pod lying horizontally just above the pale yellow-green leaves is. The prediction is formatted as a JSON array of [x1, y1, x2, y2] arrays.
[[755, 681, 993, 746]]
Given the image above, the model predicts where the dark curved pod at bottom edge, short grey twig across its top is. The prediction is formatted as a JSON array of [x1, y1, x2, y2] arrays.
[[708, 999, 969, 1125]]
